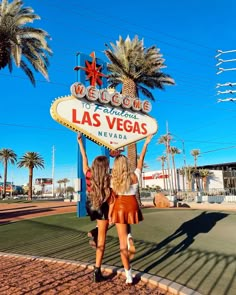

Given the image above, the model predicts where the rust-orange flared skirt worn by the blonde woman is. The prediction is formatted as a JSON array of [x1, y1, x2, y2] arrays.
[[111, 196, 143, 224]]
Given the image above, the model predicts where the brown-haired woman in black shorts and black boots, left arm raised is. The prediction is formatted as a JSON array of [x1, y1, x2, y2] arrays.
[[77, 133, 112, 283]]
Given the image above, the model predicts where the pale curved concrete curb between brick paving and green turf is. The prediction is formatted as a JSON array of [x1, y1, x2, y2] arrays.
[[0, 252, 201, 295]]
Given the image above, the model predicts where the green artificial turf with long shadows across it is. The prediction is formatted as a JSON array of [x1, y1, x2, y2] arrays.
[[0, 209, 236, 295]]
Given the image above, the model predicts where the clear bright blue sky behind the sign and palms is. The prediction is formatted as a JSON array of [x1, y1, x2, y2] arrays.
[[0, 0, 236, 185]]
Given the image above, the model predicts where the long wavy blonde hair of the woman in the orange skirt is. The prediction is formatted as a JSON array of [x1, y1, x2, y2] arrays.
[[111, 155, 131, 194]]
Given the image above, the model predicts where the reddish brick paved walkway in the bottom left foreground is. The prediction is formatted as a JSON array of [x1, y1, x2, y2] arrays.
[[0, 253, 186, 295]]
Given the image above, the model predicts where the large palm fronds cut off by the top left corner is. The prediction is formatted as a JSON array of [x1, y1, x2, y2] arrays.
[[0, 0, 52, 85]]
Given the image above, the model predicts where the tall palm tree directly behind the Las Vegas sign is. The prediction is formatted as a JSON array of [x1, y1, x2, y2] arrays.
[[105, 36, 175, 169]]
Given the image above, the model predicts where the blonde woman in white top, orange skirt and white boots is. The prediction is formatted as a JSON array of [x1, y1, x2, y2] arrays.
[[109, 135, 152, 284]]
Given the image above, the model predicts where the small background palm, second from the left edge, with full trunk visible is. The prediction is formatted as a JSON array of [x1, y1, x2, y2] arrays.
[[18, 152, 44, 201]]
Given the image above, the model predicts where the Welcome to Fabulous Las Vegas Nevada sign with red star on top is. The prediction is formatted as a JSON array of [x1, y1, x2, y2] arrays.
[[50, 53, 158, 150]]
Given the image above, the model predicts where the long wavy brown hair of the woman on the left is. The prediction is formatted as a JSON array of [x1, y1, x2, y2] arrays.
[[88, 156, 110, 210]]
